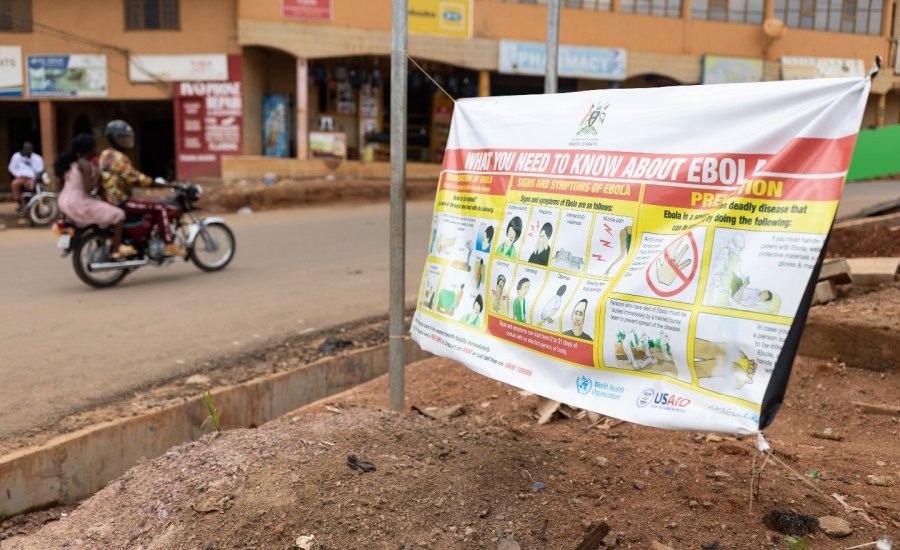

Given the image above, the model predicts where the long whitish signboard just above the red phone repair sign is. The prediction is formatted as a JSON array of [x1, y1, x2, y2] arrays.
[[128, 54, 228, 82]]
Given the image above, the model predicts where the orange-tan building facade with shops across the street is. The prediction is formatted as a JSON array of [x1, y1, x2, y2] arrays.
[[0, 0, 900, 177]]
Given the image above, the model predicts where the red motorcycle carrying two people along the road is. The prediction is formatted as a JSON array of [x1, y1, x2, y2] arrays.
[[54, 178, 235, 288]]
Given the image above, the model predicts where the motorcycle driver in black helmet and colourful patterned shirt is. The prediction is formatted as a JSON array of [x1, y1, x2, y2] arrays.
[[100, 120, 186, 256]]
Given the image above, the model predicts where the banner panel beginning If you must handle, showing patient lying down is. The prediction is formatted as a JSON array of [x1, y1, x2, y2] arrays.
[[703, 228, 825, 317]]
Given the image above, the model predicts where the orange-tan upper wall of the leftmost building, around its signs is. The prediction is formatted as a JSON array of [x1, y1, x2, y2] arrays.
[[0, 0, 241, 101]]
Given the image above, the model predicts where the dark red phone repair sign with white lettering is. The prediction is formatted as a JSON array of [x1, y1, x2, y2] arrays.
[[175, 55, 244, 179]]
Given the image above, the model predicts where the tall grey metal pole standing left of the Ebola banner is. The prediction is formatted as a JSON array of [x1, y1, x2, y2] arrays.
[[388, 0, 407, 411]]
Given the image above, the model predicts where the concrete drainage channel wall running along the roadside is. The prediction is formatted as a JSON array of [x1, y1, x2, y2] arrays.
[[0, 340, 431, 515]]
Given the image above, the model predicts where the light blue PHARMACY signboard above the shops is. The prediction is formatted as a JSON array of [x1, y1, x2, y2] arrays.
[[498, 40, 628, 80]]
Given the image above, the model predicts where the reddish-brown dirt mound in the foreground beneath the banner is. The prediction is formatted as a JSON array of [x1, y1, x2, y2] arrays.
[[4, 358, 900, 550]]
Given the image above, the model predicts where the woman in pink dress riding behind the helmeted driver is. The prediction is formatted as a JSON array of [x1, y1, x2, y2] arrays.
[[53, 134, 135, 259]]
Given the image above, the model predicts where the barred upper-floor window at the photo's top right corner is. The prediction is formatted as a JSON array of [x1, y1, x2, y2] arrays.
[[775, 0, 883, 36]]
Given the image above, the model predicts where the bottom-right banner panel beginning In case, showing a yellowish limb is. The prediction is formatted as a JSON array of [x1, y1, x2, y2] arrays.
[[692, 314, 790, 403]]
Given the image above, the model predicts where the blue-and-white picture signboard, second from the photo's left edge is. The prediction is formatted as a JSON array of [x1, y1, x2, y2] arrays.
[[28, 55, 109, 97]]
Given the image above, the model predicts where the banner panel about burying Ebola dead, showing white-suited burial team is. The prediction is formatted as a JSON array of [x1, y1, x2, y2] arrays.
[[603, 299, 692, 383]]
